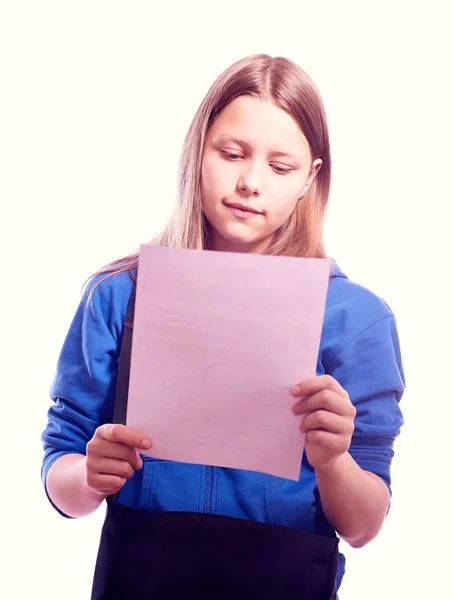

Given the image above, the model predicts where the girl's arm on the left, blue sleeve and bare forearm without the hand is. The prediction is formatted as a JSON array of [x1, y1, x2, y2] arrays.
[[41, 274, 132, 516]]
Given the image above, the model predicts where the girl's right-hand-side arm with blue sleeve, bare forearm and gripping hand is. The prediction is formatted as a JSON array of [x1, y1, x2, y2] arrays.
[[293, 317, 404, 547]]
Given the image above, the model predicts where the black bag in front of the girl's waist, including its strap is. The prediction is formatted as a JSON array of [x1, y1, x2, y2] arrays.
[[91, 286, 339, 600]]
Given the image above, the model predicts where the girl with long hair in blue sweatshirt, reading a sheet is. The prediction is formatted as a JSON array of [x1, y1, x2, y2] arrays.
[[42, 55, 404, 600]]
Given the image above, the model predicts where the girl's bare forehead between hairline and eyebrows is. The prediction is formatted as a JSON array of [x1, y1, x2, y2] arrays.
[[209, 96, 309, 154]]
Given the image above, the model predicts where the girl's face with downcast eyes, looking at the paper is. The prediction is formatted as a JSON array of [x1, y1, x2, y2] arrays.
[[201, 96, 322, 252]]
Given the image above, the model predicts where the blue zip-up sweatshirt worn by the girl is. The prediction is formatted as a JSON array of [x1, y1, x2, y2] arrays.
[[42, 265, 404, 587]]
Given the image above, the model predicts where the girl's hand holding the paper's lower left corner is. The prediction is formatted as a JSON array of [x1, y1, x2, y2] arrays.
[[86, 424, 151, 496]]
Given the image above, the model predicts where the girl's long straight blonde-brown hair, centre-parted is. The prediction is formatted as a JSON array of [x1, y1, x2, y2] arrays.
[[89, 54, 331, 282]]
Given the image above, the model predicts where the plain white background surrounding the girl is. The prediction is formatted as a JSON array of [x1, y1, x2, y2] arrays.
[[0, 0, 454, 600]]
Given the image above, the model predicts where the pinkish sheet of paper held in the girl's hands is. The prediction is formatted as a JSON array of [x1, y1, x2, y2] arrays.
[[127, 245, 331, 480]]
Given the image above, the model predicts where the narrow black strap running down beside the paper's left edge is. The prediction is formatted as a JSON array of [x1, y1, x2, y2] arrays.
[[113, 282, 136, 425]]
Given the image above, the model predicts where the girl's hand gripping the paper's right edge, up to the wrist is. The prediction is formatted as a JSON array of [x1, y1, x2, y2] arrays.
[[291, 375, 356, 470]]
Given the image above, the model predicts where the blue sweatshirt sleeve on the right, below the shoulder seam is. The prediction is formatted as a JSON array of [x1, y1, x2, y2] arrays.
[[327, 315, 405, 494]]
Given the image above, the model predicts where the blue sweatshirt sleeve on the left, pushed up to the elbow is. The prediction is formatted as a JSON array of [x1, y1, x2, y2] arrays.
[[41, 280, 124, 514]]
